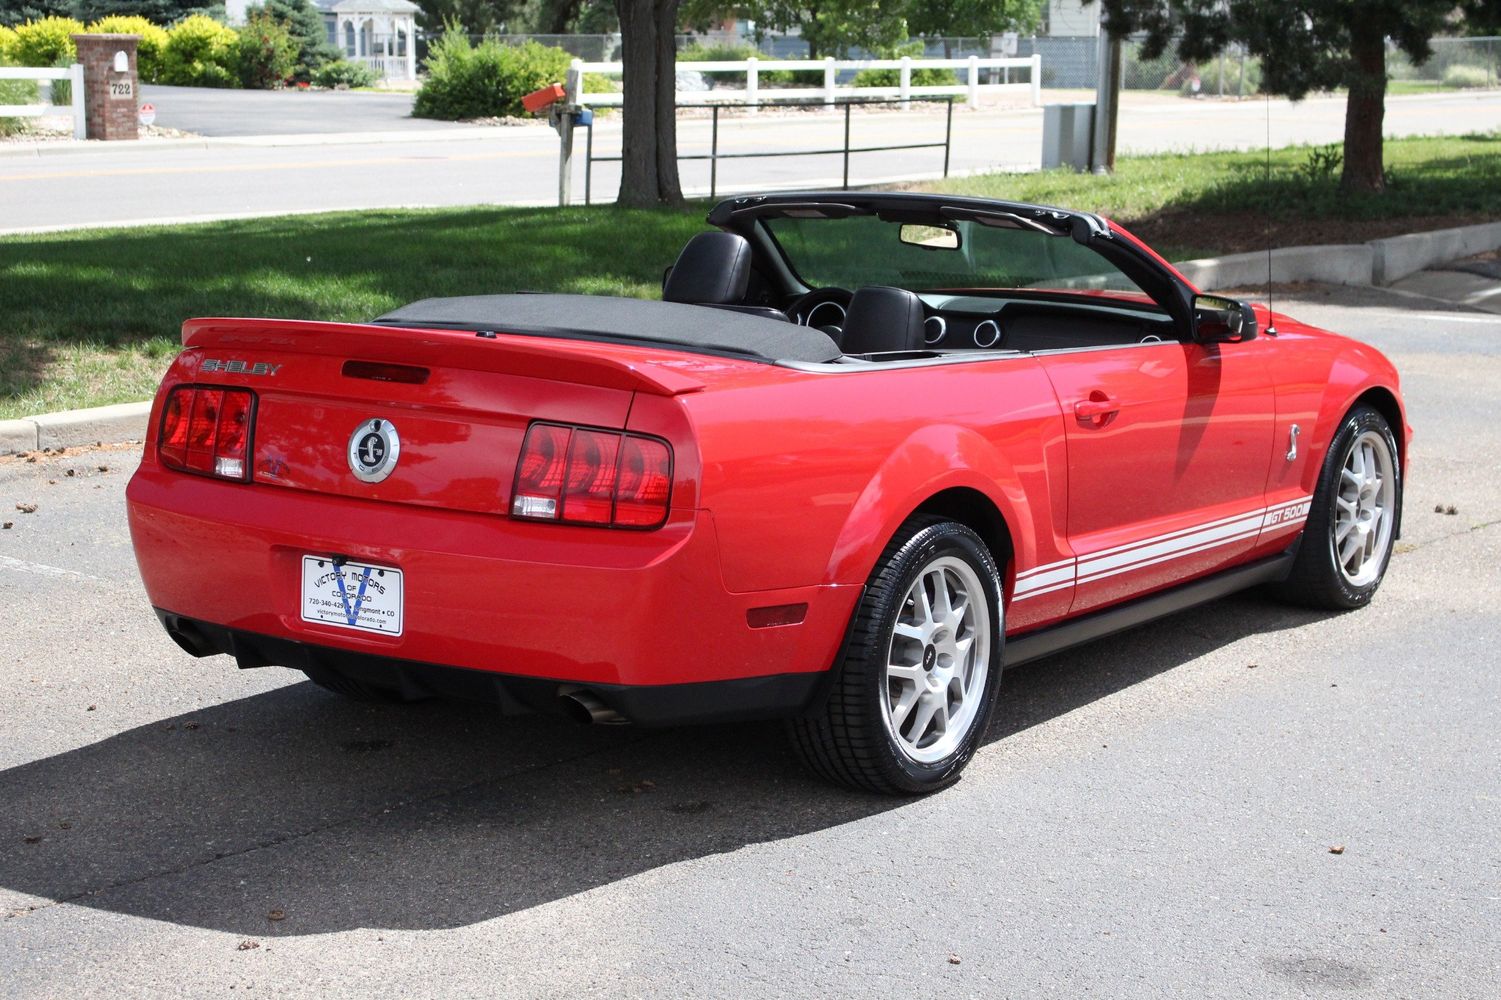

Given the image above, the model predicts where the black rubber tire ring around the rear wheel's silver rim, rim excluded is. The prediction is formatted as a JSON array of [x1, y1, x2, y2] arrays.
[[853, 521, 1006, 791]]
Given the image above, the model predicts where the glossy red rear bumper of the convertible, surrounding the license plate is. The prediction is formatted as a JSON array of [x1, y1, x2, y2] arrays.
[[126, 465, 860, 688]]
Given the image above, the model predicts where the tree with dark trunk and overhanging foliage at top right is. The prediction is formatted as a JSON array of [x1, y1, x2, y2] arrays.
[[1100, 0, 1501, 192]]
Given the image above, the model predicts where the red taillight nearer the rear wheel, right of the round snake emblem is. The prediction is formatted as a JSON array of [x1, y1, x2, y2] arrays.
[[510, 423, 672, 529]]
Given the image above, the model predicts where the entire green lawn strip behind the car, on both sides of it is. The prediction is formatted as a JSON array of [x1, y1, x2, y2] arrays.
[[0, 128, 1501, 419]]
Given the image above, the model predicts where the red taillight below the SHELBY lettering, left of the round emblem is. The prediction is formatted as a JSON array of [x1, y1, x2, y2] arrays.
[[156, 386, 255, 482]]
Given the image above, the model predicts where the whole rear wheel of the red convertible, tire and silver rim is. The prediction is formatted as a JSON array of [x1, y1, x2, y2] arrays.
[[788, 515, 1004, 794]]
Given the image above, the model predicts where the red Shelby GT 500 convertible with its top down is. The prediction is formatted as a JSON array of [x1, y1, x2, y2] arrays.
[[128, 192, 1409, 793]]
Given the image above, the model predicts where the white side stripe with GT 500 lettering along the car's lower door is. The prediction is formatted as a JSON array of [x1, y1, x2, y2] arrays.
[[1012, 497, 1313, 602]]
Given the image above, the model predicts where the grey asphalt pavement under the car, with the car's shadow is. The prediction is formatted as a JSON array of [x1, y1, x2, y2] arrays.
[[0, 283, 1501, 1000]]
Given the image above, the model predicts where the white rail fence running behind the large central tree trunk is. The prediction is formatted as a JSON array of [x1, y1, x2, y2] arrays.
[[567, 56, 1042, 108]]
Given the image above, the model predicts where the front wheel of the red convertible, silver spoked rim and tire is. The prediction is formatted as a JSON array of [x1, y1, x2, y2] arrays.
[[1277, 404, 1402, 611]]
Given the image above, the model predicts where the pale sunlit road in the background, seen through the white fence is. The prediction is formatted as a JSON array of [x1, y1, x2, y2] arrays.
[[0, 93, 1501, 233]]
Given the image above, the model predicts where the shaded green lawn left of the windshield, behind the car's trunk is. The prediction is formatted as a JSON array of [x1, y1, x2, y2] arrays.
[[0, 204, 705, 419]]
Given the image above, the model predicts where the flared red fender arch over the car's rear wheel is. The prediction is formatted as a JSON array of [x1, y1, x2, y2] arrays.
[[826, 423, 1039, 584]]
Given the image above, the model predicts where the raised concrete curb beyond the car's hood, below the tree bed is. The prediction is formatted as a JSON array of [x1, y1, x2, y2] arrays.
[[1174, 222, 1501, 291]]
